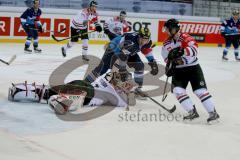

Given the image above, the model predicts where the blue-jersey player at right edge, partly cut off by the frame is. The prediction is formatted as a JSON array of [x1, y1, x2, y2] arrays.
[[221, 10, 240, 61]]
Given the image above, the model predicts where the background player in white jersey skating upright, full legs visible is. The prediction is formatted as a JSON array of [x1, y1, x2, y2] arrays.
[[62, 1, 102, 61]]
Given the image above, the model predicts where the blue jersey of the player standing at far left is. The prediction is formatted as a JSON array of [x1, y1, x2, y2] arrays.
[[21, 8, 42, 26]]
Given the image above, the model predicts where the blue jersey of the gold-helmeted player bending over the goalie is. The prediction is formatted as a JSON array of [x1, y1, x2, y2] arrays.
[[109, 32, 154, 62]]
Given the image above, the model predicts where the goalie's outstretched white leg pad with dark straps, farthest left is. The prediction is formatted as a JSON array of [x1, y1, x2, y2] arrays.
[[8, 81, 48, 102]]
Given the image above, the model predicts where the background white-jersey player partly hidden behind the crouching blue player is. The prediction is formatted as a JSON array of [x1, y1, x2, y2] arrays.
[[104, 11, 129, 40]]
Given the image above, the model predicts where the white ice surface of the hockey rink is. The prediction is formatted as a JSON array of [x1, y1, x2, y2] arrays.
[[0, 43, 240, 160]]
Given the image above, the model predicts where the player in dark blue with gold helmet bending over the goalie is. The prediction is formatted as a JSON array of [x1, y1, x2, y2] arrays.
[[85, 28, 158, 96]]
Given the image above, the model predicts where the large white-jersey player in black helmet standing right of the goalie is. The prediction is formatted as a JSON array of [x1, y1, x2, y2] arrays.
[[162, 19, 219, 122]]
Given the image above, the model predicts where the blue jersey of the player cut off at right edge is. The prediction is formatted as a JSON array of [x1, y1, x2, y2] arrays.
[[221, 17, 240, 35]]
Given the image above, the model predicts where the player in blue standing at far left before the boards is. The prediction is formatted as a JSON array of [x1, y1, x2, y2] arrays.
[[21, 0, 43, 53]]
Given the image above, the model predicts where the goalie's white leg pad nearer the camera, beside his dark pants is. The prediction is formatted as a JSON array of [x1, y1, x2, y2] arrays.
[[48, 92, 87, 115]]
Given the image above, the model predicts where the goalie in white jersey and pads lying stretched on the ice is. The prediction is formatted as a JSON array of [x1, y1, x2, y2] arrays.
[[8, 72, 135, 114]]
